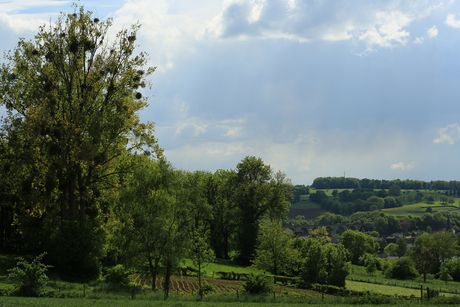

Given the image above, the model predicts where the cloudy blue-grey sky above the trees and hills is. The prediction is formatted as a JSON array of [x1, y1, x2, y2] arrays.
[[0, 0, 460, 185]]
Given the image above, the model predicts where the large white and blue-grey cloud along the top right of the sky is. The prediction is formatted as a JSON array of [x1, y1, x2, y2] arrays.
[[207, 0, 443, 52]]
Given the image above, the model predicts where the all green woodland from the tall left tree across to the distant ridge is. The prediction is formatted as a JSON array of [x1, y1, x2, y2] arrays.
[[0, 5, 460, 302]]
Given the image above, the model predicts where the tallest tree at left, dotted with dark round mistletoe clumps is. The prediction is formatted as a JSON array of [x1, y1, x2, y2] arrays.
[[0, 4, 160, 280]]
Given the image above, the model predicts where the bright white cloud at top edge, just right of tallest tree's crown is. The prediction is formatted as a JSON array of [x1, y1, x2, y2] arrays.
[[114, 0, 221, 72]]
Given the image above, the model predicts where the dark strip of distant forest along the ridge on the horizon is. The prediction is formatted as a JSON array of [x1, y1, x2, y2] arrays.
[[311, 177, 460, 191]]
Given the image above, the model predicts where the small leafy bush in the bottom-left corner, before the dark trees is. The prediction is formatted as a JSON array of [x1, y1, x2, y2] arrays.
[[8, 253, 51, 296]]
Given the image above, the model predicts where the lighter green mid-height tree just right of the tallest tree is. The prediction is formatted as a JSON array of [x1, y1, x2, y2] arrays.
[[115, 156, 190, 295]]
